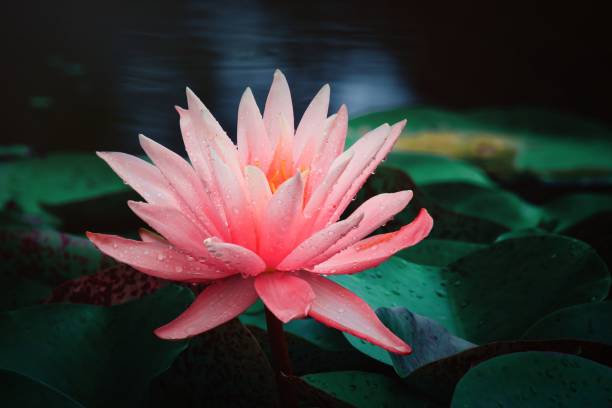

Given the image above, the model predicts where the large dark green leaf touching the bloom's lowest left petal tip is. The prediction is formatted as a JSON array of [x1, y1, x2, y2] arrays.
[[0, 286, 193, 407]]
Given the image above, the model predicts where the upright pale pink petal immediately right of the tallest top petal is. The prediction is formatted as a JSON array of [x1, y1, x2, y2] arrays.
[[293, 85, 329, 168]]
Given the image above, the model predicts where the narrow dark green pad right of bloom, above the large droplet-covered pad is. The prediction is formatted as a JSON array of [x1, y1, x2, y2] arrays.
[[423, 183, 542, 229]]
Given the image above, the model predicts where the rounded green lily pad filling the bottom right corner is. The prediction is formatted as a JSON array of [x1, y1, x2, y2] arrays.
[[451, 352, 612, 408]]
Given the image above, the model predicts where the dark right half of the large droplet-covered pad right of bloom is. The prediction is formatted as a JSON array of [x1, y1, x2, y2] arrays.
[[445, 235, 610, 343]]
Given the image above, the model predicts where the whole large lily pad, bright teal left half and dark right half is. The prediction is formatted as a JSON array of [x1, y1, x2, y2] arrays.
[[331, 235, 610, 363]]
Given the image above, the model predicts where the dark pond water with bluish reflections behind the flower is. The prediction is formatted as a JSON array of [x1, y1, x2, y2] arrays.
[[2, 0, 612, 152]]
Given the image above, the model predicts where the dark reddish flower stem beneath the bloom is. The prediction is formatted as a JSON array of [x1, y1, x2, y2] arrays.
[[266, 307, 298, 408]]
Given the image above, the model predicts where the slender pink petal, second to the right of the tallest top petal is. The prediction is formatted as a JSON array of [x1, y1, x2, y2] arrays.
[[306, 105, 348, 197]]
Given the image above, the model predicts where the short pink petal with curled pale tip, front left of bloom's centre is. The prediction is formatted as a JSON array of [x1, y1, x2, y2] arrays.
[[204, 238, 266, 276]]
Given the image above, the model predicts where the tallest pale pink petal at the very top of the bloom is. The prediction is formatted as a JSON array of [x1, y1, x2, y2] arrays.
[[263, 69, 295, 146]]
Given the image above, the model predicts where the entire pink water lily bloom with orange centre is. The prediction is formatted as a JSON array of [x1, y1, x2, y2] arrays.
[[88, 71, 433, 354]]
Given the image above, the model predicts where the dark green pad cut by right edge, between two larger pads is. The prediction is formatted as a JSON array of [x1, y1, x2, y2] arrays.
[[523, 301, 612, 345]]
